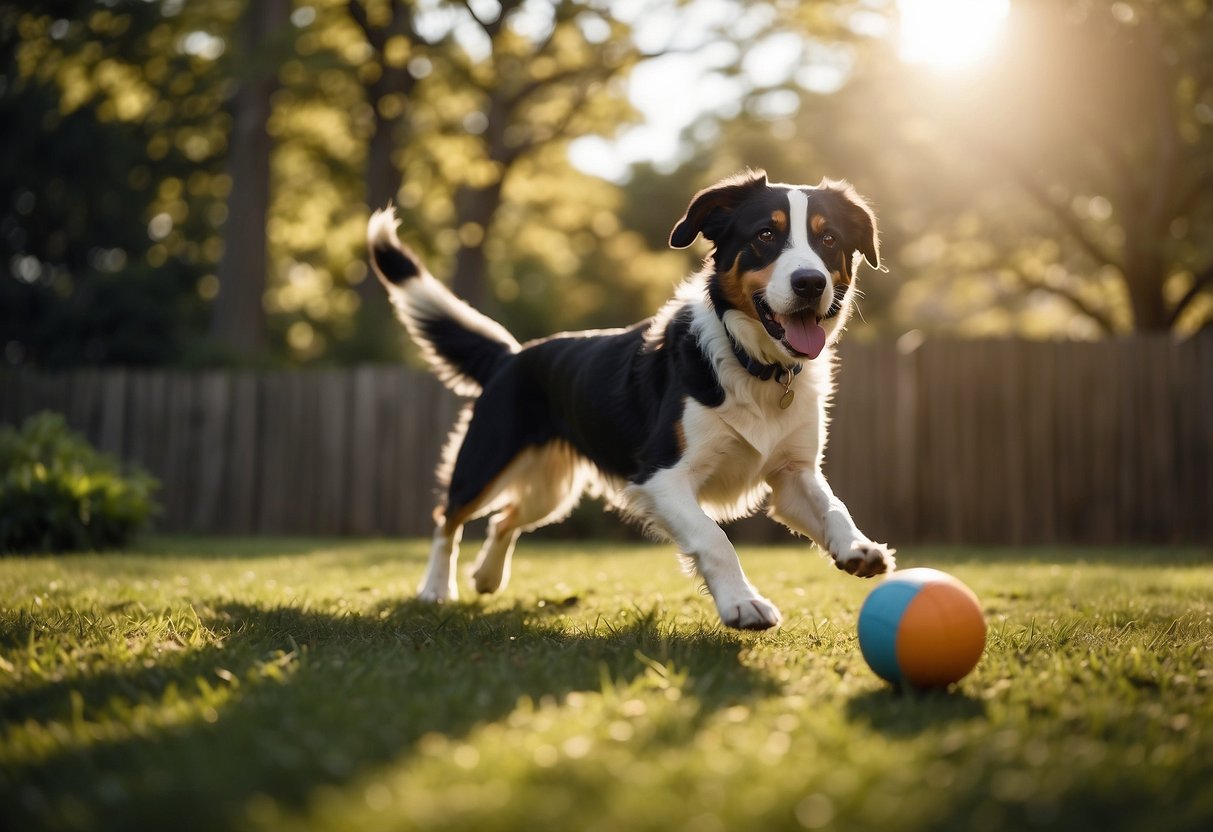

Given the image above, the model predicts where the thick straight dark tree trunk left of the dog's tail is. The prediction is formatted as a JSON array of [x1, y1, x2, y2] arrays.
[[211, 0, 291, 357]]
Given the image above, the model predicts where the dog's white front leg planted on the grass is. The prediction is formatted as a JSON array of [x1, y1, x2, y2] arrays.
[[628, 468, 782, 629]]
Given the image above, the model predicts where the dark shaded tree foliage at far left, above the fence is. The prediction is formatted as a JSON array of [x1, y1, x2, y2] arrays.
[[0, 1, 228, 366]]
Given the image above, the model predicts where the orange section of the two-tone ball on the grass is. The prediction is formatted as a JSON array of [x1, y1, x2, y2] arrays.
[[896, 576, 986, 688]]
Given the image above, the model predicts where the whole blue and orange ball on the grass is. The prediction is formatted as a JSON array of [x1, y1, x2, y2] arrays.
[[859, 568, 986, 689]]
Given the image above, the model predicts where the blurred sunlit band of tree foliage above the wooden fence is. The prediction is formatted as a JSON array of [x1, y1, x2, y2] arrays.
[[0, 0, 1213, 366]]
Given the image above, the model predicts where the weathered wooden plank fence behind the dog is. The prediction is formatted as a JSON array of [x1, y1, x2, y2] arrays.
[[0, 337, 1213, 545]]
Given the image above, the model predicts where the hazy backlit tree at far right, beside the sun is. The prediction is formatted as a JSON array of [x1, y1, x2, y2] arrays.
[[967, 2, 1213, 331]]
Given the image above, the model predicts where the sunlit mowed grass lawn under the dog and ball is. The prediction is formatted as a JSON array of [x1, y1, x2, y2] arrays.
[[0, 538, 1213, 832]]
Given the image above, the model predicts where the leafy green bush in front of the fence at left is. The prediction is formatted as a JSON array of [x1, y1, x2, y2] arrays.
[[0, 412, 160, 552]]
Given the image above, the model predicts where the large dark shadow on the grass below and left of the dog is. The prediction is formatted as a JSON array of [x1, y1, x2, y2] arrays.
[[0, 603, 778, 830]]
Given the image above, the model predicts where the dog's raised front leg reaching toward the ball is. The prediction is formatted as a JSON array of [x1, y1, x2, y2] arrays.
[[767, 466, 896, 577]]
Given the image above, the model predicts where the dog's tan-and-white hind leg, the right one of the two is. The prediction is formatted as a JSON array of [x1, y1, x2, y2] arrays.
[[472, 443, 586, 593]]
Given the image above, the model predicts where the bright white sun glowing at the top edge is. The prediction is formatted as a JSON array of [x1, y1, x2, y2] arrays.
[[898, 0, 1010, 69]]
